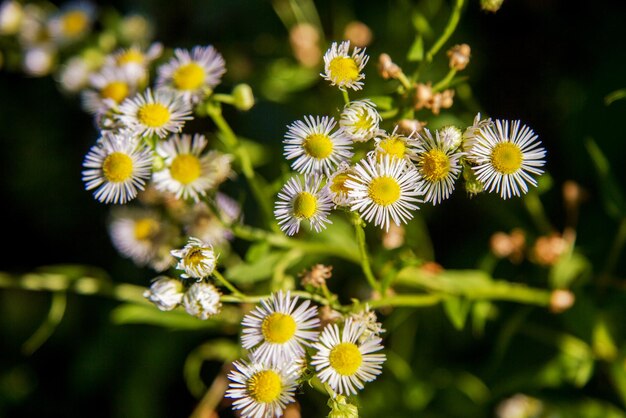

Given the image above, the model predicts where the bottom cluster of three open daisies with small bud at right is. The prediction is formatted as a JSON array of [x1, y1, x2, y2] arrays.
[[226, 291, 385, 418]]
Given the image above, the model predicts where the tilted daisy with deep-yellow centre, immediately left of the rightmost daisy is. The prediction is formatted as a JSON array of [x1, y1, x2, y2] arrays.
[[414, 128, 463, 205]]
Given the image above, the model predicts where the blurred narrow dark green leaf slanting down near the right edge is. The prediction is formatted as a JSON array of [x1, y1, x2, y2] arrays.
[[585, 138, 626, 219]]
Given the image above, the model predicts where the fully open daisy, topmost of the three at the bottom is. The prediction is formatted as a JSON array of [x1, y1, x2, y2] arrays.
[[241, 290, 320, 365]]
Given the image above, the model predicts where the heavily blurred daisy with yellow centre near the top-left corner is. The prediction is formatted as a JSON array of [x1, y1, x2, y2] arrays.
[[48, 1, 96, 44]]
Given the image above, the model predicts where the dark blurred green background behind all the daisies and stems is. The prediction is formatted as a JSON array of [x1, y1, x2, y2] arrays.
[[0, 0, 626, 418]]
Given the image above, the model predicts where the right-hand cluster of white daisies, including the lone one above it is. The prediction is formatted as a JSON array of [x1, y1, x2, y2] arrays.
[[274, 41, 545, 235]]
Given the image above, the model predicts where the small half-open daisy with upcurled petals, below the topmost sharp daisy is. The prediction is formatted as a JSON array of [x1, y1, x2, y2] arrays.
[[339, 100, 382, 142]]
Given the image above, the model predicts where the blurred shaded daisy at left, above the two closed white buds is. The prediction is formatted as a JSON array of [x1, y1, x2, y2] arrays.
[[109, 207, 177, 271]]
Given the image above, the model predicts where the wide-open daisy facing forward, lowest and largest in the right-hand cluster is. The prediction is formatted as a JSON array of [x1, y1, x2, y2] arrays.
[[346, 155, 423, 231]]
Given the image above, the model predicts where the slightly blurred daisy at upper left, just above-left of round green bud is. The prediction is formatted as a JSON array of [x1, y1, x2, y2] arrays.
[[157, 45, 226, 103]]
